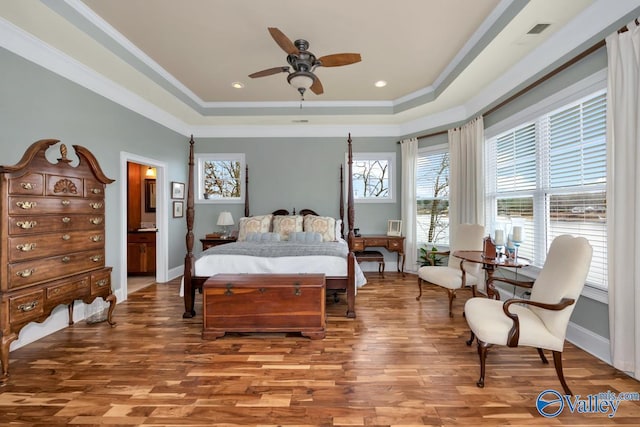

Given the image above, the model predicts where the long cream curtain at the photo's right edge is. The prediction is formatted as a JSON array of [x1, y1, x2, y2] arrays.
[[606, 22, 640, 379]]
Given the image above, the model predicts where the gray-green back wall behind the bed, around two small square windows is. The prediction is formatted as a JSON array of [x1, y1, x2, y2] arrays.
[[194, 135, 401, 252]]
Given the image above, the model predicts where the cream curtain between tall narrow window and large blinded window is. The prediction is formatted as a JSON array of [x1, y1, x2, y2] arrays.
[[449, 116, 484, 246]]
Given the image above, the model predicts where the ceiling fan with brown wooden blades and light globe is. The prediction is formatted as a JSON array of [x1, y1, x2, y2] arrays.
[[249, 27, 362, 96]]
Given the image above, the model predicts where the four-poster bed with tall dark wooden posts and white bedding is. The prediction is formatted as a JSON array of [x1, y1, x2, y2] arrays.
[[183, 135, 366, 318]]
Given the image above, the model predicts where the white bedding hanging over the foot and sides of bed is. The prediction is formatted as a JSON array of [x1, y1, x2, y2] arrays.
[[180, 254, 367, 296]]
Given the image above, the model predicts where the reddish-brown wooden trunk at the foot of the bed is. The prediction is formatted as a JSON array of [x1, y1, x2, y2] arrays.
[[202, 274, 326, 339]]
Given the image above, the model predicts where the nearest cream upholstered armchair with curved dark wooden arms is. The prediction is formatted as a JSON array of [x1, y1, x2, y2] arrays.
[[464, 235, 593, 394]]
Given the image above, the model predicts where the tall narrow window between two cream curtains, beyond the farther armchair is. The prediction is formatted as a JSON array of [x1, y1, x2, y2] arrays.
[[416, 144, 449, 245]]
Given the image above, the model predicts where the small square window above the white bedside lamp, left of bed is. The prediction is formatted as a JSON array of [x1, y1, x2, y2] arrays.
[[195, 154, 245, 203]]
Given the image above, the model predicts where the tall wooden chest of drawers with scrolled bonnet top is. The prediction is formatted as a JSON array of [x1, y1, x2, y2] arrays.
[[0, 139, 116, 381]]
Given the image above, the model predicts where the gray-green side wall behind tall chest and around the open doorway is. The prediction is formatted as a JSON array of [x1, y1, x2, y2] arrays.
[[0, 49, 188, 289]]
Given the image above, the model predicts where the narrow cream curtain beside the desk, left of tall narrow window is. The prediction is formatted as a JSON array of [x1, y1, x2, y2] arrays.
[[400, 138, 418, 272]]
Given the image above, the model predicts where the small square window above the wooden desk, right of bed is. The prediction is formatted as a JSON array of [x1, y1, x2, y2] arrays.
[[352, 153, 396, 203]]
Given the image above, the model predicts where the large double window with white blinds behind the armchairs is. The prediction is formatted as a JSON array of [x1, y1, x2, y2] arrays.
[[486, 91, 607, 289]]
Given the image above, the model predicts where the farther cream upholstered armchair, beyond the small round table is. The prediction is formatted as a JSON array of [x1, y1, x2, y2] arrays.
[[416, 224, 484, 317]]
